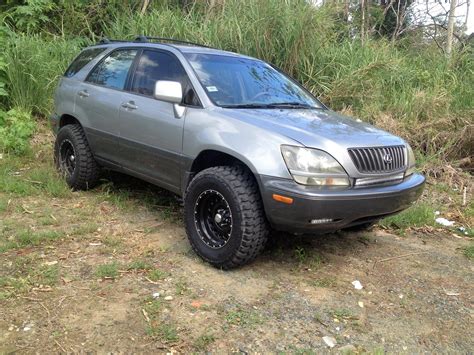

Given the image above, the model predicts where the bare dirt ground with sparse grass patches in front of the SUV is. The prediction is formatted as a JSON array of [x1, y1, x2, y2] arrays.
[[0, 131, 474, 354]]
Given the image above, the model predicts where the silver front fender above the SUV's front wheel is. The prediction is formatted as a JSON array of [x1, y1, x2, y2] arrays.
[[183, 108, 299, 179]]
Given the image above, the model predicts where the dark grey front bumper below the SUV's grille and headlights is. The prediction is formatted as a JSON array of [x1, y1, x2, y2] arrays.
[[259, 174, 425, 233]]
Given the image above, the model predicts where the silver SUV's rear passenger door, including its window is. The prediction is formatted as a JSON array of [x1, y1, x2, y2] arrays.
[[75, 48, 138, 164]]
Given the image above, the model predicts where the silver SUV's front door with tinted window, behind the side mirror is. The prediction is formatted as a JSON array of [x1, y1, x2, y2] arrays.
[[119, 49, 198, 191]]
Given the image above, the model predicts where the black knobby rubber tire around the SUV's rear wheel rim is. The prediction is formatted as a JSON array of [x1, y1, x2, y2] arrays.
[[54, 124, 100, 190]]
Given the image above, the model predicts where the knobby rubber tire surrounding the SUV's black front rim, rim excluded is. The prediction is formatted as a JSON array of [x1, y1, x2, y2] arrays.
[[184, 166, 269, 269]]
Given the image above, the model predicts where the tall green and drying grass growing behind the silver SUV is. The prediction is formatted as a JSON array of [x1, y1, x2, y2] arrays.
[[5, 0, 474, 156]]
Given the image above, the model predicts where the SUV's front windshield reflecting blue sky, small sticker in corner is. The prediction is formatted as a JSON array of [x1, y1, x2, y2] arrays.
[[186, 53, 322, 108]]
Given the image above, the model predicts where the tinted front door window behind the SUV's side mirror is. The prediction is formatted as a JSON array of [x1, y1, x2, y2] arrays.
[[131, 50, 199, 106]]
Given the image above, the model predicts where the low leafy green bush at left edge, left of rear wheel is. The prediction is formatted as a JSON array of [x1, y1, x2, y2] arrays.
[[0, 109, 36, 154]]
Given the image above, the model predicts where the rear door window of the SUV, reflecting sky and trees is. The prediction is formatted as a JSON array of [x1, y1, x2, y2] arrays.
[[86, 49, 137, 90]]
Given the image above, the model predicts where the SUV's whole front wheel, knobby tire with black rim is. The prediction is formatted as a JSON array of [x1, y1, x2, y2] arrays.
[[184, 166, 268, 269]]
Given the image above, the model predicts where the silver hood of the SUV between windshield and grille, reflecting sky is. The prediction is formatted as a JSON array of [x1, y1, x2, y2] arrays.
[[222, 109, 405, 150]]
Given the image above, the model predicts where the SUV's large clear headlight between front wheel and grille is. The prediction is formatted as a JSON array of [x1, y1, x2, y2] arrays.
[[281, 145, 350, 186]]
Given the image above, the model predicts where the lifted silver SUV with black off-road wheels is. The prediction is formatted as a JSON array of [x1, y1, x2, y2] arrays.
[[51, 37, 425, 269]]
